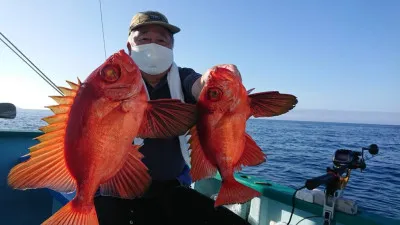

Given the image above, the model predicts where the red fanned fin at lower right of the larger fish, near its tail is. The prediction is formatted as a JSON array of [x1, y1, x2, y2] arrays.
[[100, 145, 151, 199]]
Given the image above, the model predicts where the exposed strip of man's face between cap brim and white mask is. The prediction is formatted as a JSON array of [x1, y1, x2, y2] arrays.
[[131, 24, 173, 49]]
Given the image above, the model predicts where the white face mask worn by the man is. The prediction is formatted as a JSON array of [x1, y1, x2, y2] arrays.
[[131, 43, 174, 75]]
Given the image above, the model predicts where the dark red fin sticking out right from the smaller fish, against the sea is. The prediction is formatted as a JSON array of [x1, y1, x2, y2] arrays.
[[249, 91, 297, 117]]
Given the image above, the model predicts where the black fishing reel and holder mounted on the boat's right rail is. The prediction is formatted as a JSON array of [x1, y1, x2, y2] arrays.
[[287, 144, 379, 225]]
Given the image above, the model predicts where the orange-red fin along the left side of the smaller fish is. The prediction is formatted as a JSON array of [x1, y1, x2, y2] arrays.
[[189, 126, 217, 182]]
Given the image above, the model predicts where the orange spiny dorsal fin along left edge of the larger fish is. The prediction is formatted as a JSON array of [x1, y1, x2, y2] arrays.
[[8, 80, 80, 192]]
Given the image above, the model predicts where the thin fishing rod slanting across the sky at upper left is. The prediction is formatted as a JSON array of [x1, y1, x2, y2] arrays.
[[0, 32, 64, 95]]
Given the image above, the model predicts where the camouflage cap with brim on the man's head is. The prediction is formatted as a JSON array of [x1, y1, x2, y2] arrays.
[[128, 11, 181, 35]]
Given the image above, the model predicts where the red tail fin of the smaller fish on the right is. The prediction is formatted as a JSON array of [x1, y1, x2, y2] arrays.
[[214, 178, 261, 207]]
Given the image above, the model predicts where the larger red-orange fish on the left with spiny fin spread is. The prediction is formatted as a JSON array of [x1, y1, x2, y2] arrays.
[[8, 50, 196, 225]]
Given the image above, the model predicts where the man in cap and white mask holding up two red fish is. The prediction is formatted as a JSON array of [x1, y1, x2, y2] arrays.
[[95, 11, 245, 225]]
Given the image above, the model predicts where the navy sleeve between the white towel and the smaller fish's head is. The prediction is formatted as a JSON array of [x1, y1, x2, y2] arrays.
[[179, 68, 201, 104]]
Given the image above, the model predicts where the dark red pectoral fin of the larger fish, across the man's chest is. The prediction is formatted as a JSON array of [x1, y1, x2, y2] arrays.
[[137, 99, 197, 139]]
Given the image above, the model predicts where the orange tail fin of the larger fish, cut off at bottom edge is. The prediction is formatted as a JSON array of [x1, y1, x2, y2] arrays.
[[41, 200, 99, 225]]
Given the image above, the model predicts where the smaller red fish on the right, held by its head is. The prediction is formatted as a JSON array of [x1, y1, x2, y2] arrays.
[[189, 66, 297, 207]]
